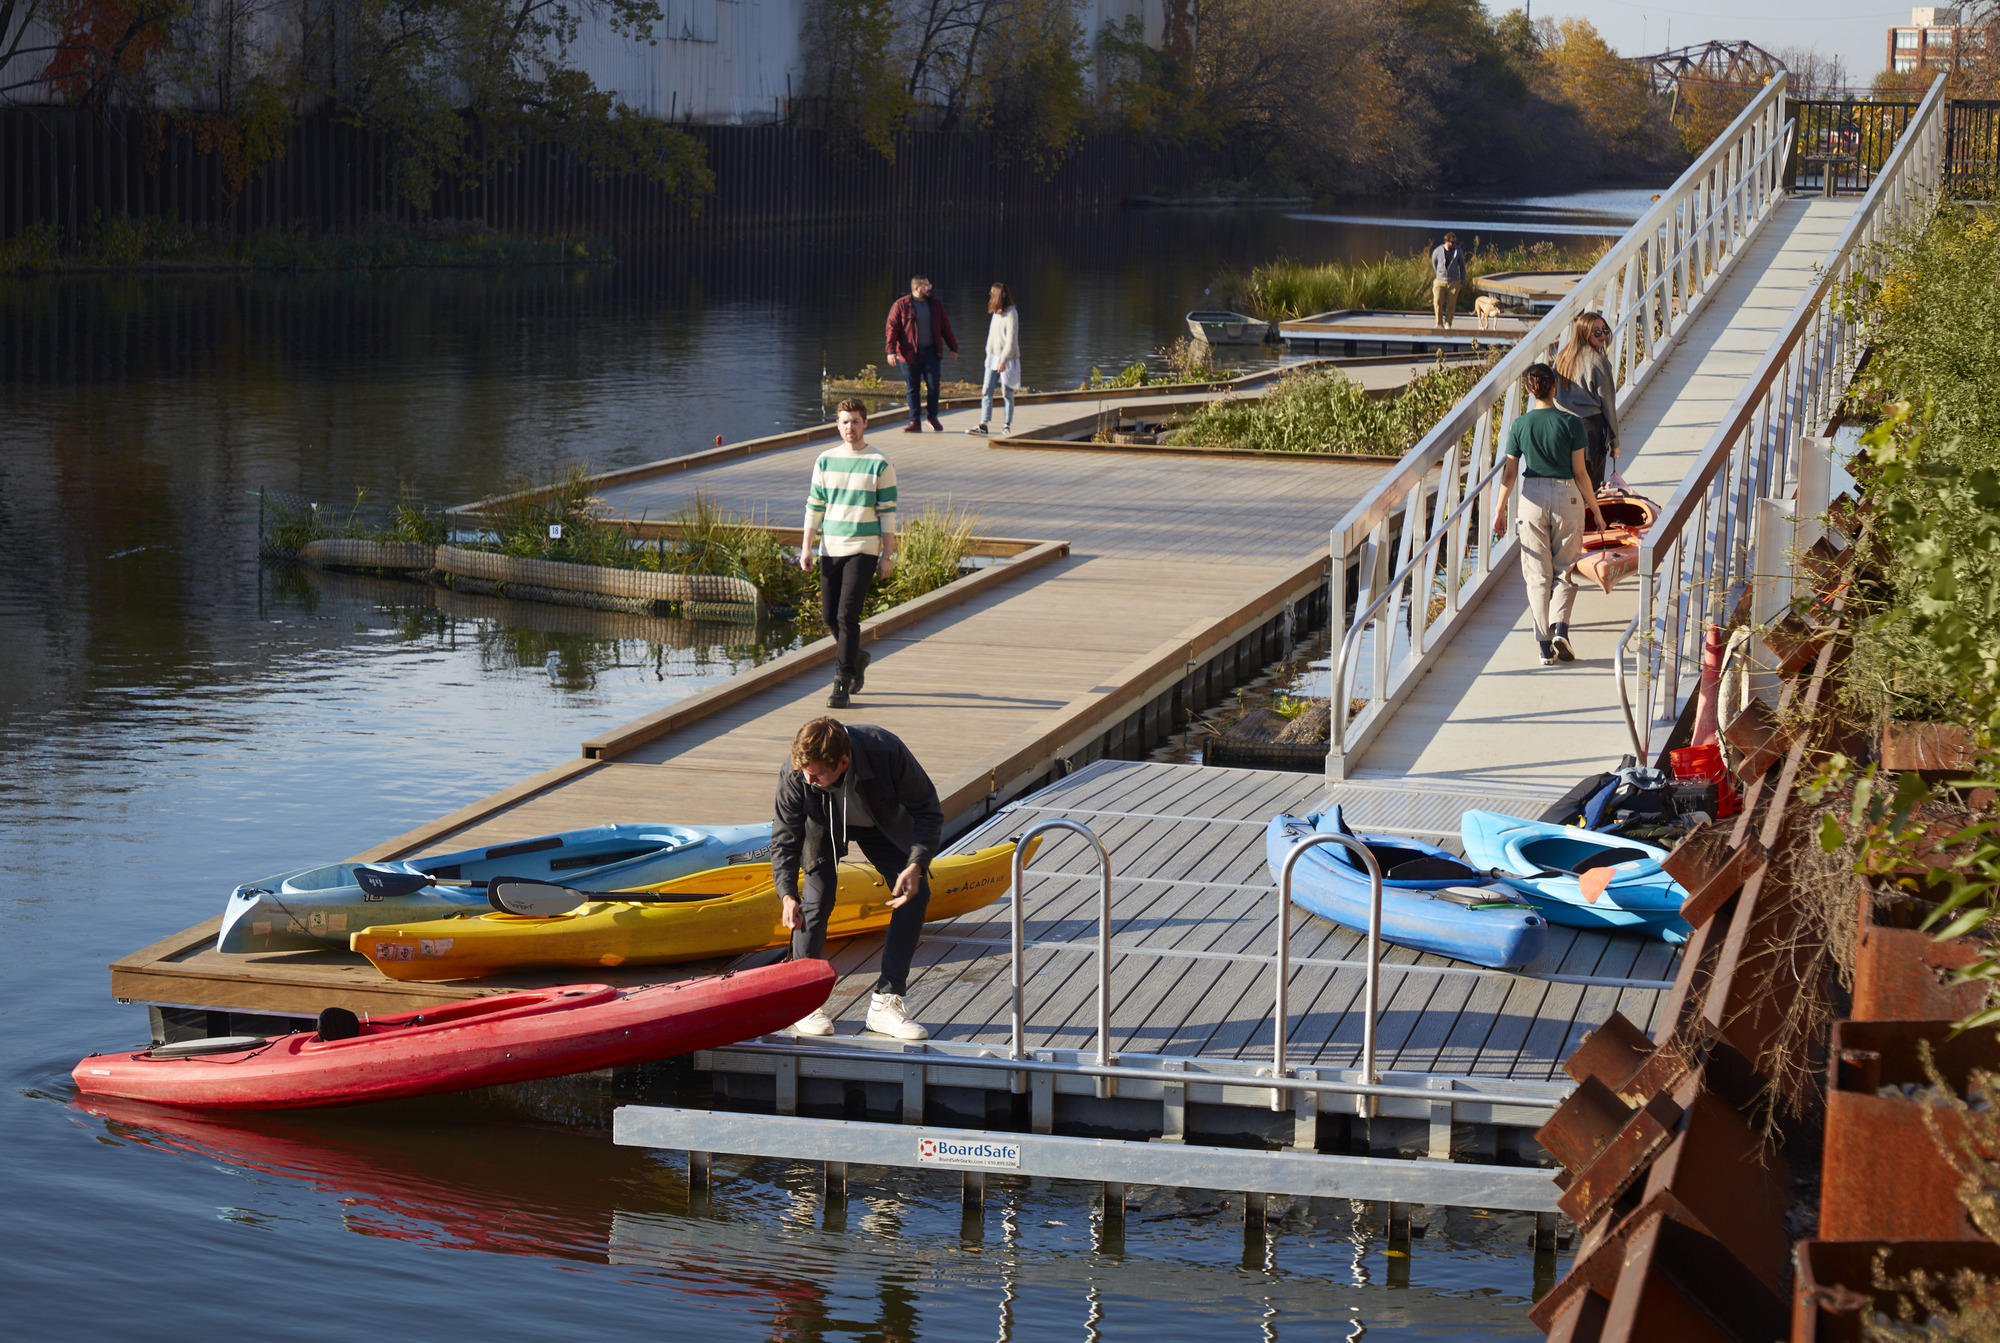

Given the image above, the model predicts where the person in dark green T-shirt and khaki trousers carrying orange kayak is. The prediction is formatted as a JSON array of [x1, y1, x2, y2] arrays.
[[1494, 364, 1604, 668]]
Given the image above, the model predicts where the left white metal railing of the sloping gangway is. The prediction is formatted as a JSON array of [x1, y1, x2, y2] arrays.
[[1326, 74, 1790, 779]]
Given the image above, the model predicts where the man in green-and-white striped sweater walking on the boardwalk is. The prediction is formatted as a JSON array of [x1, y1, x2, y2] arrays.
[[798, 400, 896, 709]]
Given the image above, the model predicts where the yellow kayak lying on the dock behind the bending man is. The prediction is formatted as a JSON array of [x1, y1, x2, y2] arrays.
[[348, 839, 1040, 979]]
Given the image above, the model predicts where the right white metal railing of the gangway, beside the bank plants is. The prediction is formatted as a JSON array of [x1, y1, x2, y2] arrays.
[[1608, 74, 1948, 761]]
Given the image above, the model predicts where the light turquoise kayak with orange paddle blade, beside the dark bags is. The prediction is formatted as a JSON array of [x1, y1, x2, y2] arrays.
[[1458, 811, 1690, 943]]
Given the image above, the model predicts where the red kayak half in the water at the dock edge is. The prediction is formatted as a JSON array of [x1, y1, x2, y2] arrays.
[[70, 961, 834, 1109]]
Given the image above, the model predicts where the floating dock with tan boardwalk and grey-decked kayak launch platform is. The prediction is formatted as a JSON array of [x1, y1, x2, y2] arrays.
[[112, 363, 1674, 1245]]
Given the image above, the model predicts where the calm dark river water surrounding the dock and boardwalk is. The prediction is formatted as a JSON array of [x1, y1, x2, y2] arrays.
[[0, 192, 1646, 1341]]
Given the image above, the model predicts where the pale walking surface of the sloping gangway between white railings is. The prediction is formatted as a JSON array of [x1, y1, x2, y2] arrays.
[[1350, 198, 1860, 787]]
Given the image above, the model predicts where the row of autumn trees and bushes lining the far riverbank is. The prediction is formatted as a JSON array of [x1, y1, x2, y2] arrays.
[[0, 0, 1744, 235]]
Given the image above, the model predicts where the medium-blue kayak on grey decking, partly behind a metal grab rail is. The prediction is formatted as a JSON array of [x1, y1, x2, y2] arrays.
[[1264, 807, 1548, 969]]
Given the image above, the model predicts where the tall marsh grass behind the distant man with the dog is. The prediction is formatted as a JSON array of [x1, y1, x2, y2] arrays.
[[1212, 240, 1604, 322]]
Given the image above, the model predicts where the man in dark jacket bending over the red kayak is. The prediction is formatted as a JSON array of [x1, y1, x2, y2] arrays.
[[770, 717, 944, 1039]]
